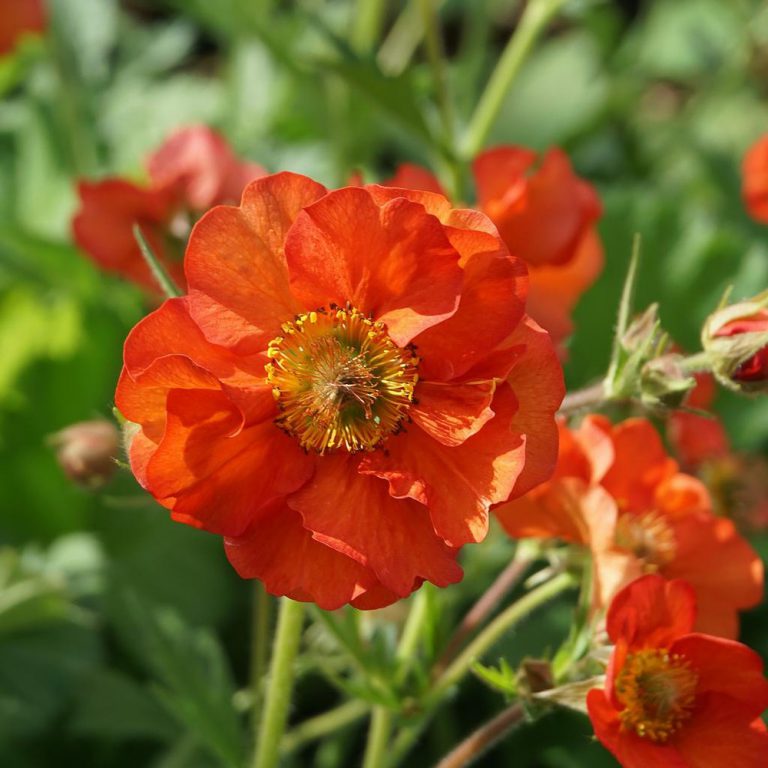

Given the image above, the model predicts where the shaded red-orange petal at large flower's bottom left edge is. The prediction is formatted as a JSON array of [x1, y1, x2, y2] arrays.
[[224, 500, 390, 611]]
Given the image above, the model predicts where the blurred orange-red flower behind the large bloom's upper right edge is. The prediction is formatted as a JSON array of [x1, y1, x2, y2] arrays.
[[380, 146, 603, 352]]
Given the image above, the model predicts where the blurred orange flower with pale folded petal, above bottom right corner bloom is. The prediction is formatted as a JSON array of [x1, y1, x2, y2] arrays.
[[496, 416, 763, 638]]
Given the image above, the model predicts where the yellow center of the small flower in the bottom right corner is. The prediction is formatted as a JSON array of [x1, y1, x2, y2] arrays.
[[615, 648, 699, 743]]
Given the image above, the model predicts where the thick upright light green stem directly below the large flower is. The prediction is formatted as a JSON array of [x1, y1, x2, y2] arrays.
[[252, 597, 304, 768]]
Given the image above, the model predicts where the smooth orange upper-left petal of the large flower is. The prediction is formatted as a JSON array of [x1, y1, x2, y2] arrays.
[[184, 173, 325, 353]]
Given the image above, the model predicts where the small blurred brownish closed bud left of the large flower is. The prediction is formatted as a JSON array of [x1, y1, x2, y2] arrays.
[[49, 419, 119, 488]]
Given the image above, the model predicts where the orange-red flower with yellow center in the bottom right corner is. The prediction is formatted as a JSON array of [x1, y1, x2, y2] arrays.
[[587, 575, 768, 768]]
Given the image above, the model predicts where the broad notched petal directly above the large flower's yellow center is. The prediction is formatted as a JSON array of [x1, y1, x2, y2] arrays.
[[285, 187, 463, 346]]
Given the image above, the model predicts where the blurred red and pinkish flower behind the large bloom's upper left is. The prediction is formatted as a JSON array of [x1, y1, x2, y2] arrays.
[[72, 126, 265, 293]]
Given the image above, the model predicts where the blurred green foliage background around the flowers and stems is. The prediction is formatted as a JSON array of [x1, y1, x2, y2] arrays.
[[0, 0, 768, 768]]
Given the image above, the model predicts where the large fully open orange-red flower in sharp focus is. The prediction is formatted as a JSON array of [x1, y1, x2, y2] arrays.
[[116, 173, 563, 609]]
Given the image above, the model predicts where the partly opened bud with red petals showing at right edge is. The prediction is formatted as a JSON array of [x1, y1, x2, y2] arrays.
[[701, 291, 768, 393]]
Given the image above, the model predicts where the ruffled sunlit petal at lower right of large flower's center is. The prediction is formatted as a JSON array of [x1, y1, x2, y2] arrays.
[[360, 385, 525, 547]]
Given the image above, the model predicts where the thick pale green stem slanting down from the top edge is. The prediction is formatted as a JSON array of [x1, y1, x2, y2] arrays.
[[463, 0, 565, 158]]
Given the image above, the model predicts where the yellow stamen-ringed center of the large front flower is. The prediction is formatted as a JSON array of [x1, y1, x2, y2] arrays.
[[266, 304, 419, 453]]
